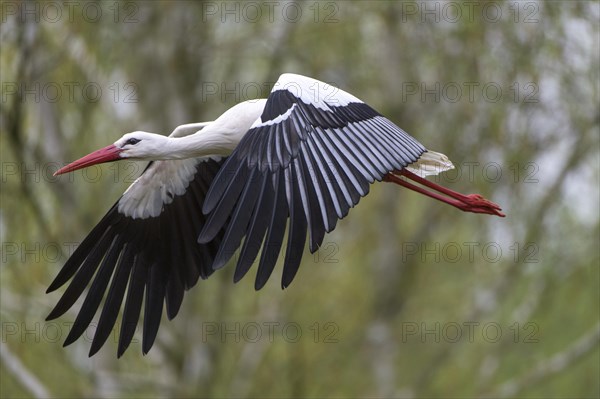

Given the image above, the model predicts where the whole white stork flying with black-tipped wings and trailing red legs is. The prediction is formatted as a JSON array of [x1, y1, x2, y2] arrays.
[[47, 73, 504, 357]]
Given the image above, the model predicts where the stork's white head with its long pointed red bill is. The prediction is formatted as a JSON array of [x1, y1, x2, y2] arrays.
[[54, 131, 168, 176]]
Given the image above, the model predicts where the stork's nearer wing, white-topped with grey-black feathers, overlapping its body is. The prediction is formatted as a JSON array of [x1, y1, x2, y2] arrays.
[[199, 74, 426, 289]]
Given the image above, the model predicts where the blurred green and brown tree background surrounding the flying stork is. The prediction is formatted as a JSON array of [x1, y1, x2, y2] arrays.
[[0, 1, 600, 397]]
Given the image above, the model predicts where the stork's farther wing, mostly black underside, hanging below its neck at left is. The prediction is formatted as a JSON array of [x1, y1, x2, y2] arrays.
[[47, 157, 224, 357]]
